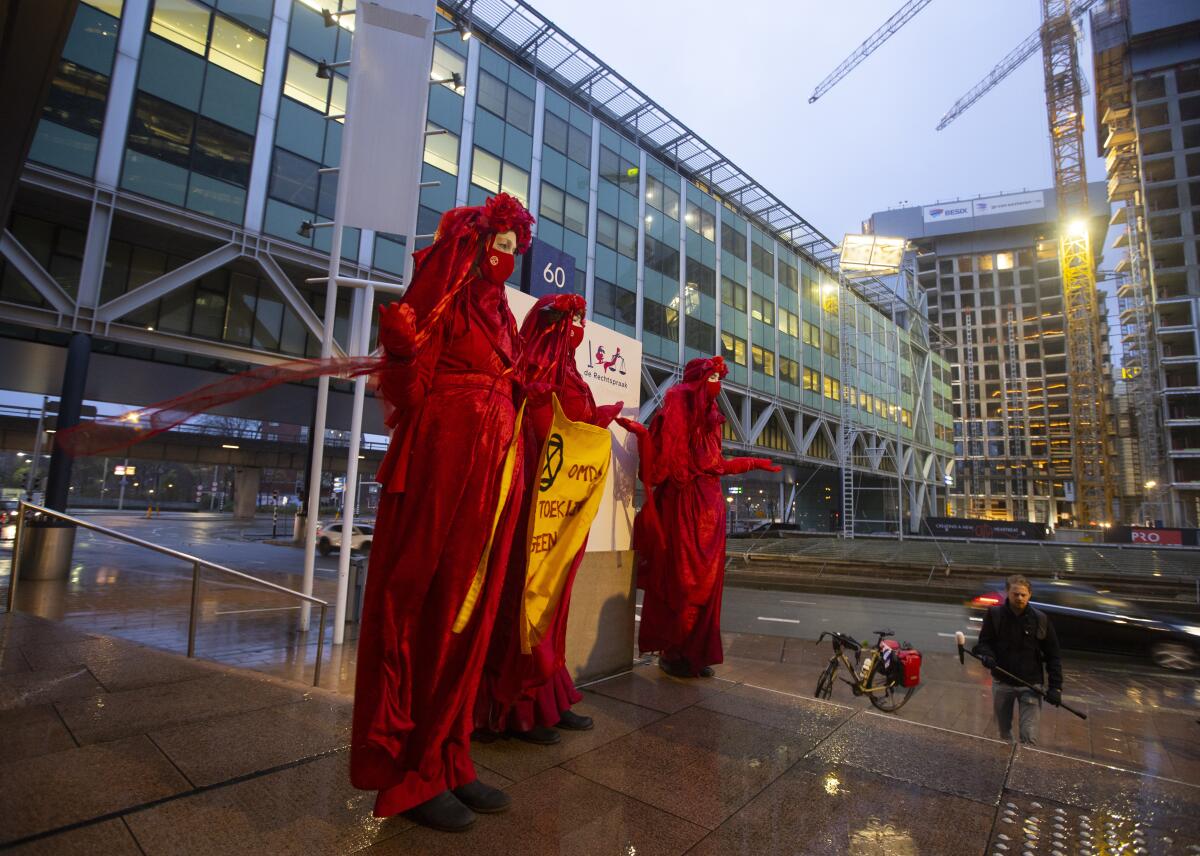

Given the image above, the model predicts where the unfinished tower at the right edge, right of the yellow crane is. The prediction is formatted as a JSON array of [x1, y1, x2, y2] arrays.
[[1091, 0, 1200, 527]]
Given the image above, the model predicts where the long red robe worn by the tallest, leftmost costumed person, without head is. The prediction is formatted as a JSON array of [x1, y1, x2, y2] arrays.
[[350, 273, 523, 816]]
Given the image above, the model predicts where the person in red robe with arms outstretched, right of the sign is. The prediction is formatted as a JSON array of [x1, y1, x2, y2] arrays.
[[617, 357, 781, 677]]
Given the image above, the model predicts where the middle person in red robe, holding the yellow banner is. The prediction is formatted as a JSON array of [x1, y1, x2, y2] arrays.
[[475, 294, 623, 744]]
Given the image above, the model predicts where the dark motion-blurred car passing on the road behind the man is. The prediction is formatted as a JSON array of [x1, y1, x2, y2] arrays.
[[966, 580, 1200, 671]]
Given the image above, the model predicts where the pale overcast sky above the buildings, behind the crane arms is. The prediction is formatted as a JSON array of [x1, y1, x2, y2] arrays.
[[530, 0, 1104, 241]]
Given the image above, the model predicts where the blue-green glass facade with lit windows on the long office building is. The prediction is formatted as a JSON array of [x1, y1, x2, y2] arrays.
[[7, 0, 955, 504]]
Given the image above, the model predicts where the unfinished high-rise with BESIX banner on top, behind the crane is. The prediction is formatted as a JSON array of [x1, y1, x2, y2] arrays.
[[869, 182, 1116, 526]]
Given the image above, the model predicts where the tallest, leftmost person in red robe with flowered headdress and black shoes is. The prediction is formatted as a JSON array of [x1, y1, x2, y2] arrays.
[[350, 193, 533, 831]]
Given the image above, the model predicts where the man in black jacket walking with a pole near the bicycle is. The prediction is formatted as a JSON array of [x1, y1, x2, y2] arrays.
[[974, 574, 1062, 746]]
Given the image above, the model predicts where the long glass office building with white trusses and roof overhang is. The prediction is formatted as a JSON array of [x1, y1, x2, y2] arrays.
[[0, 0, 953, 529]]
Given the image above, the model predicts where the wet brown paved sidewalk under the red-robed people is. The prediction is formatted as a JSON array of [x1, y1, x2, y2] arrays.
[[0, 613, 1200, 856]]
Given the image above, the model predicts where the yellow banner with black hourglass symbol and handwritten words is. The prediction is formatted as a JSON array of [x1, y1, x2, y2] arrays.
[[521, 396, 612, 654]]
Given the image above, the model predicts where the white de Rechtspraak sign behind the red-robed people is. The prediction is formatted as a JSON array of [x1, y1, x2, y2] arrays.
[[508, 287, 642, 552]]
